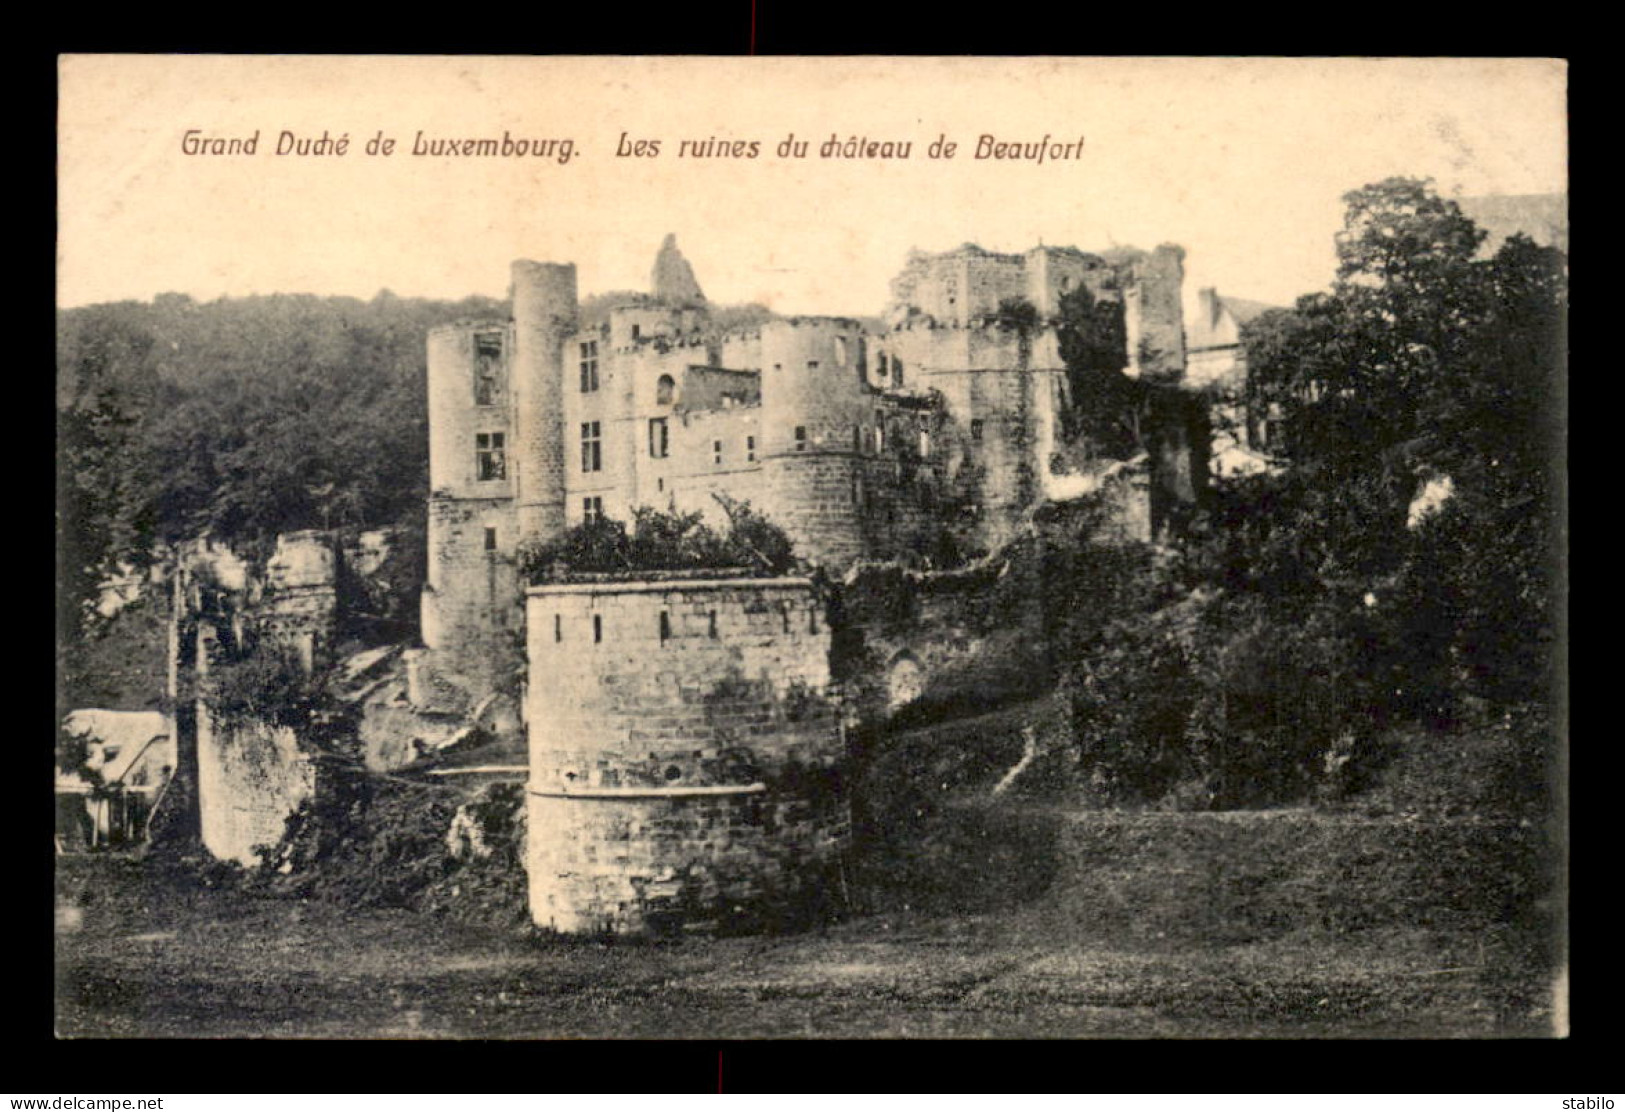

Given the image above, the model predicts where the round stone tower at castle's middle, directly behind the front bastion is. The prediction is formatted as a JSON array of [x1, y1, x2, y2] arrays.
[[762, 317, 874, 567]]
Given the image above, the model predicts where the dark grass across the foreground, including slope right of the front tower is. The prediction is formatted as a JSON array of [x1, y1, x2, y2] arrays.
[[57, 699, 1560, 1039]]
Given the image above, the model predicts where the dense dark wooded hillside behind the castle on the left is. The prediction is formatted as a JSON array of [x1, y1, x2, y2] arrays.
[[57, 291, 772, 708]]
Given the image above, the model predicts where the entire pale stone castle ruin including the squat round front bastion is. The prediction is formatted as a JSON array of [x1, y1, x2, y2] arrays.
[[408, 236, 1185, 933]]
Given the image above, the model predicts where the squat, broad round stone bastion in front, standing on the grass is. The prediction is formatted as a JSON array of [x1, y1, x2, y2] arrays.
[[527, 579, 850, 933]]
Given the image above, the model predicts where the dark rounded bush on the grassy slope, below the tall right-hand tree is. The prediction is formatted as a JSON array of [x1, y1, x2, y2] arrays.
[[1068, 559, 1393, 810]]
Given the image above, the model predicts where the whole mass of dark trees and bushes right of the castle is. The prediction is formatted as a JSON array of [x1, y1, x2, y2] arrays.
[[1068, 179, 1567, 806]]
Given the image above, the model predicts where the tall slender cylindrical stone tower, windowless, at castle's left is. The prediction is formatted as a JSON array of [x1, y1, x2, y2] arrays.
[[514, 258, 577, 540]]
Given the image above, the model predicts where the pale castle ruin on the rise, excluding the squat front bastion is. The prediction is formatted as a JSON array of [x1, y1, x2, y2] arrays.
[[414, 236, 1185, 706]]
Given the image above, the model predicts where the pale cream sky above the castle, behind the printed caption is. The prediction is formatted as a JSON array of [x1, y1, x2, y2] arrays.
[[59, 55, 1568, 314]]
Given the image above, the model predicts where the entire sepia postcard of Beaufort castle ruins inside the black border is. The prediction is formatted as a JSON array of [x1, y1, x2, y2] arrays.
[[54, 54, 1570, 1040]]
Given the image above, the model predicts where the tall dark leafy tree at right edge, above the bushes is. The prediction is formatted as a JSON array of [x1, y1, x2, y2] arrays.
[[1243, 179, 1567, 708]]
